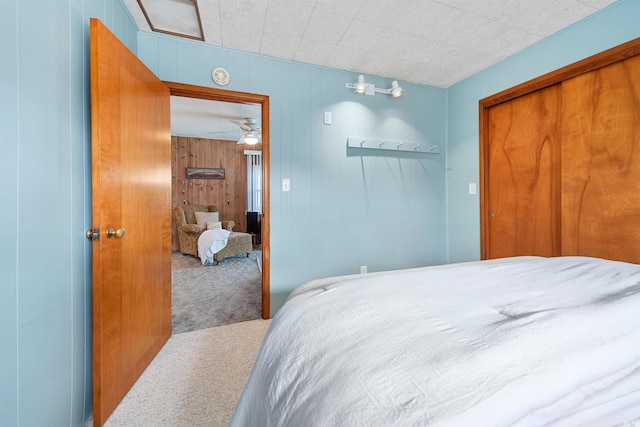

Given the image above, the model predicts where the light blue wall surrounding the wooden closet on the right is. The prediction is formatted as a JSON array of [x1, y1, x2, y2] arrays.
[[447, 0, 640, 262]]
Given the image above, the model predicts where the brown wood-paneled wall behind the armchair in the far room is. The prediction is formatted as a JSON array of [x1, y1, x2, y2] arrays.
[[171, 136, 261, 250]]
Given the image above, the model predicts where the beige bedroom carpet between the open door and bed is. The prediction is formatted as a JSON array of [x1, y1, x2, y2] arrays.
[[104, 319, 270, 427]]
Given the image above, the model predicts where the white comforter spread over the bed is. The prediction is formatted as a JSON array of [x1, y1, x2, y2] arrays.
[[230, 257, 640, 426]]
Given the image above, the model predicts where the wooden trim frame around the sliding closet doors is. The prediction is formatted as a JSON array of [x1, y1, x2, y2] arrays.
[[479, 37, 640, 260]]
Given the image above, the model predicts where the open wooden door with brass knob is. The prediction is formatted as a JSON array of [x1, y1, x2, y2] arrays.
[[90, 19, 171, 425]]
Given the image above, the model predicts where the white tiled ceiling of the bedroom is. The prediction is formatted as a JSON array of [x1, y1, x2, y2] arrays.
[[125, 0, 615, 88]]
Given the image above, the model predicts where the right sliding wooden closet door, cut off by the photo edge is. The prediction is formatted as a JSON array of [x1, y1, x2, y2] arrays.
[[562, 56, 640, 263]]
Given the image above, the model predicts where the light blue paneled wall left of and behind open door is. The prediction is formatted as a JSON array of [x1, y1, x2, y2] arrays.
[[0, 0, 137, 427]]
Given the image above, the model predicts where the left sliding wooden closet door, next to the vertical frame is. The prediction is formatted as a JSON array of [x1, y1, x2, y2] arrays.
[[484, 85, 561, 258]]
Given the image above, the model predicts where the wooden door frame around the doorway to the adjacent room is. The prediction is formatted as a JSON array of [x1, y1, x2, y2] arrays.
[[164, 81, 271, 319]]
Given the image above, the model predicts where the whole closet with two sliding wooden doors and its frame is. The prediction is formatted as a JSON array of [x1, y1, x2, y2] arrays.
[[480, 39, 640, 263]]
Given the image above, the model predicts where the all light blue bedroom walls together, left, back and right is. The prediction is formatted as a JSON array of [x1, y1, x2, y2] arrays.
[[0, 0, 640, 426]]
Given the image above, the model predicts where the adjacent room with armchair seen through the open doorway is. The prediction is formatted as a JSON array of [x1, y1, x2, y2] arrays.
[[170, 96, 262, 334]]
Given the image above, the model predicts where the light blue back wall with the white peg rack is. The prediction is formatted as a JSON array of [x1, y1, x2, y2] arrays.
[[138, 32, 446, 314]]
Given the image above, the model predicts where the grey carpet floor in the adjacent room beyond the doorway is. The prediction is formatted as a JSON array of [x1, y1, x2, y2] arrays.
[[171, 250, 262, 334]]
